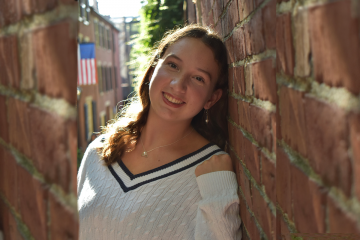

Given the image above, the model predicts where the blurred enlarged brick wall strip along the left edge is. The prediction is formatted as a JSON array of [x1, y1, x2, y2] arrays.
[[0, 0, 78, 240]]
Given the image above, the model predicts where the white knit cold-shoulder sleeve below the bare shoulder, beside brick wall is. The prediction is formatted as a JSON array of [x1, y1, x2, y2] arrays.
[[195, 171, 242, 240]]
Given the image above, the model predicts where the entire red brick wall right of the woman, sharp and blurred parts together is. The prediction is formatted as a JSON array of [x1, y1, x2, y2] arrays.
[[187, 0, 360, 240]]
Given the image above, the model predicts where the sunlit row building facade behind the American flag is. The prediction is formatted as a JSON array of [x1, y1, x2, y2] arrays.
[[78, 0, 123, 152]]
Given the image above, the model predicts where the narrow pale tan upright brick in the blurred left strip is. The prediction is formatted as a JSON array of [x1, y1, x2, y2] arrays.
[[20, 33, 36, 90]]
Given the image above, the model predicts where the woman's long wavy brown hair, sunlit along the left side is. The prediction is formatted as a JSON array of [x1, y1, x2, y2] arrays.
[[98, 24, 228, 165]]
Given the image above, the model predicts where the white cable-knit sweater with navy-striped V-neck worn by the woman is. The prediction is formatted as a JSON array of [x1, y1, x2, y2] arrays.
[[78, 136, 241, 240]]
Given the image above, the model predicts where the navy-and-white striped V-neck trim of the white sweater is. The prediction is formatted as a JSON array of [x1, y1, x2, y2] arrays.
[[108, 143, 222, 192]]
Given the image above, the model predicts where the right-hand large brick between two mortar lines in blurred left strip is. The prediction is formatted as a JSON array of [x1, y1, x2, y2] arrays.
[[29, 107, 74, 192]]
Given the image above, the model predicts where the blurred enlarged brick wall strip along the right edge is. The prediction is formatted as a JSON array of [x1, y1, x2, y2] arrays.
[[276, 0, 360, 239]]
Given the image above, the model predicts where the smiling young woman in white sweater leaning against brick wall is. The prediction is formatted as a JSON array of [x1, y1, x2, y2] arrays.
[[78, 25, 241, 240]]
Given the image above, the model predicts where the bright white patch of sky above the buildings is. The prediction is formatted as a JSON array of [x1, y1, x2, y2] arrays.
[[89, 0, 146, 20]]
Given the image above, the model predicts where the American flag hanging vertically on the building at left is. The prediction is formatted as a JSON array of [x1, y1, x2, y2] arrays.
[[78, 43, 97, 86]]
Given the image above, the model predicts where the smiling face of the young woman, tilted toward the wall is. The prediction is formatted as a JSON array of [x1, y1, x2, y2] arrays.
[[149, 38, 222, 124]]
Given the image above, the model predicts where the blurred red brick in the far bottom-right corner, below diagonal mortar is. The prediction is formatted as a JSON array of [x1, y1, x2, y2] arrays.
[[327, 196, 360, 235]]
